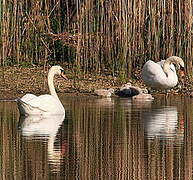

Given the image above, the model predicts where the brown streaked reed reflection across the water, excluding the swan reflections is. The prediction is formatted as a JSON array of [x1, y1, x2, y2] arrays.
[[0, 97, 193, 180]]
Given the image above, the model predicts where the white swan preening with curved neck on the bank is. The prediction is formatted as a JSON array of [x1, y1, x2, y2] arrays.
[[141, 56, 184, 89]]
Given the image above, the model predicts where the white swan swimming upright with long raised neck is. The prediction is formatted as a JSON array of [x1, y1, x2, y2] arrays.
[[17, 66, 66, 115]]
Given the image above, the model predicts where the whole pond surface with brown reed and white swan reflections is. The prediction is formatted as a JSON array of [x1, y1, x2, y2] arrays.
[[0, 96, 193, 180]]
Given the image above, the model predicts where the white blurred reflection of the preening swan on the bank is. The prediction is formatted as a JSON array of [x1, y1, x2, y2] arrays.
[[142, 107, 178, 139]]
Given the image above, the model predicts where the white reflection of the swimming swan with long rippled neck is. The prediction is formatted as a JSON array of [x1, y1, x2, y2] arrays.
[[20, 115, 65, 170]]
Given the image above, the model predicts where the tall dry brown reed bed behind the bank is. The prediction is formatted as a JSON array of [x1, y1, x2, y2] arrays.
[[0, 0, 193, 77]]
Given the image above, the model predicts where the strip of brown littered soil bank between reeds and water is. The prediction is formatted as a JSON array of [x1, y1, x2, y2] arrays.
[[0, 66, 193, 100]]
